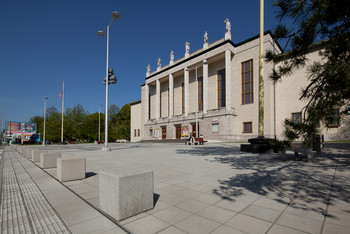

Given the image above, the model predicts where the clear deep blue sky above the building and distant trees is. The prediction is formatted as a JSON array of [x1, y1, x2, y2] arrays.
[[0, 0, 278, 127]]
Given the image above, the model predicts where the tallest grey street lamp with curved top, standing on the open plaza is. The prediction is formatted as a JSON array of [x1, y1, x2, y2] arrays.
[[97, 11, 121, 151]]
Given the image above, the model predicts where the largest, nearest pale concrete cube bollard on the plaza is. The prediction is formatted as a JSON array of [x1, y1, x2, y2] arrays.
[[99, 168, 154, 221]]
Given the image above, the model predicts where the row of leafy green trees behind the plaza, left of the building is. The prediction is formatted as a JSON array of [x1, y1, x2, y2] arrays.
[[30, 104, 130, 142]]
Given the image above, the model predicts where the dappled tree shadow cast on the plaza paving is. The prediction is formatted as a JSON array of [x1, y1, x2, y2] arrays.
[[177, 144, 350, 218]]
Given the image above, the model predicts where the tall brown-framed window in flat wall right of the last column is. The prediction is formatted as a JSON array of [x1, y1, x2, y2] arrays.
[[242, 59, 253, 104]]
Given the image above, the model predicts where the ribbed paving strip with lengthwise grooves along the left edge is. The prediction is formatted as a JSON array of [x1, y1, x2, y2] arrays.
[[1, 147, 71, 233]]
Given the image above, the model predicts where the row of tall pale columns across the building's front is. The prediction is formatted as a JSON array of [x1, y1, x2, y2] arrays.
[[144, 50, 231, 122]]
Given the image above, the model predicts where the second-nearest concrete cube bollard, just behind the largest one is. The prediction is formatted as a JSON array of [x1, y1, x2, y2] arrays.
[[57, 156, 86, 182]]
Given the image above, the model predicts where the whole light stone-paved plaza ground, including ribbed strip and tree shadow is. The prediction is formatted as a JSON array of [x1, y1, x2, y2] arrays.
[[0, 143, 350, 234]]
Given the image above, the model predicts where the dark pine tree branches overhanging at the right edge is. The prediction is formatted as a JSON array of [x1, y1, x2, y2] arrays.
[[266, 0, 350, 142]]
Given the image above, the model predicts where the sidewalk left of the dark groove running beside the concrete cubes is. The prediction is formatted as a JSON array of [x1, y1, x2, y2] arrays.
[[1, 147, 125, 233]]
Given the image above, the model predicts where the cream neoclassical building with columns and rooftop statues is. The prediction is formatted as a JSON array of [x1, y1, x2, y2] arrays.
[[131, 20, 348, 142]]
